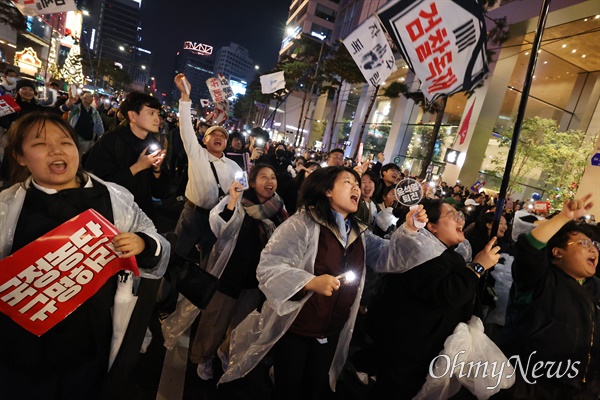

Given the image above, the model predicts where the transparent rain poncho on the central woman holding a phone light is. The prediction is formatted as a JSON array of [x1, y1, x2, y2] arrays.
[[219, 211, 389, 390]]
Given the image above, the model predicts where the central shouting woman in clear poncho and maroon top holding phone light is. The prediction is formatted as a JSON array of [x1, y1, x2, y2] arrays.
[[219, 167, 412, 400]]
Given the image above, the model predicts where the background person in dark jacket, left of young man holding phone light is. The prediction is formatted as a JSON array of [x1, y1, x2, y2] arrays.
[[69, 92, 104, 154]]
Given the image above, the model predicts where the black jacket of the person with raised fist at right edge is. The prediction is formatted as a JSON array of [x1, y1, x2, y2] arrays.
[[501, 235, 600, 399]]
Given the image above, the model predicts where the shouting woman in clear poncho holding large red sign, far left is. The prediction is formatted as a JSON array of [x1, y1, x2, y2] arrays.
[[0, 113, 169, 399]]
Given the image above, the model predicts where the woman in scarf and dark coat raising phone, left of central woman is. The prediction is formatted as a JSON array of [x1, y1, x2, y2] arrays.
[[190, 164, 288, 380]]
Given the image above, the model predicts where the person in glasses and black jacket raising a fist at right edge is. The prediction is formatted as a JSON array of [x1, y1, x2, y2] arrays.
[[500, 194, 600, 400]]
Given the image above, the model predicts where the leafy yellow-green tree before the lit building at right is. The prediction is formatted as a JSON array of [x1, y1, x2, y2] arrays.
[[492, 117, 595, 200]]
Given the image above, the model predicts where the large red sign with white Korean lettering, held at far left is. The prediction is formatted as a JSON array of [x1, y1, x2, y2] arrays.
[[0, 209, 139, 336]]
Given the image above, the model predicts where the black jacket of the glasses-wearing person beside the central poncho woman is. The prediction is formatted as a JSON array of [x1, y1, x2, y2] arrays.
[[367, 248, 479, 398]]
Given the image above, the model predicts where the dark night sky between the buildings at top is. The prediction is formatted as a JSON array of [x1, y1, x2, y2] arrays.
[[140, 0, 291, 93]]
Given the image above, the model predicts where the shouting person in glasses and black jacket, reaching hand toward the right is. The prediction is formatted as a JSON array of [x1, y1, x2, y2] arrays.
[[367, 198, 500, 399]]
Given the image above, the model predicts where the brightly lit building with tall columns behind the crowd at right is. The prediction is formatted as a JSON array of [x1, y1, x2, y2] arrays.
[[298, 0, 600, 215]]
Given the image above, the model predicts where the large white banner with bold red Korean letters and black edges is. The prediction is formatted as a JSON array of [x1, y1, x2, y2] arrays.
[[377, 0, 489, 101]]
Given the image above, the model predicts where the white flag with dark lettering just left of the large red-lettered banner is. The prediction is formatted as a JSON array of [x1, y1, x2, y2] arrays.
[[343, 15, 398, 86]]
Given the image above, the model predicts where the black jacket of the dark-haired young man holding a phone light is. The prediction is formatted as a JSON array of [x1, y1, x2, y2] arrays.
[[84, 125, 169, 223]]
